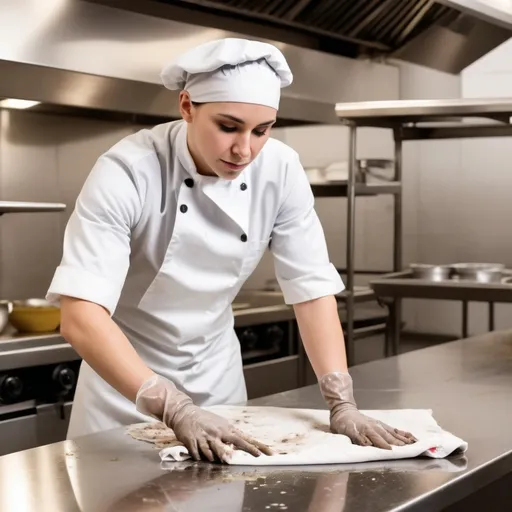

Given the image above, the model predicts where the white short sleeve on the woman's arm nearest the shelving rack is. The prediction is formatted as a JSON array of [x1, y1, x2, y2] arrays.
[[270, 153, 345, 304]]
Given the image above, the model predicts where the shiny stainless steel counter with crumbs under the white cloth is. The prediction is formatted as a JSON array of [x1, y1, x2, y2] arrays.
[[0, 331, 512, 512]]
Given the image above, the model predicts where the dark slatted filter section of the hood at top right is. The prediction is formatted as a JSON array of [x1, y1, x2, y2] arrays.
[[100, 0, 512, 74]]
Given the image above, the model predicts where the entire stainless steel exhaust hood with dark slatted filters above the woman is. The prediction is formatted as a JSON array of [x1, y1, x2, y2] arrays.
[[0, 0, 512, 126]]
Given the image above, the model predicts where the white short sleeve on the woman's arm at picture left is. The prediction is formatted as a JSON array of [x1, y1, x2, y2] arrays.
[[47, 154, 142, 315]]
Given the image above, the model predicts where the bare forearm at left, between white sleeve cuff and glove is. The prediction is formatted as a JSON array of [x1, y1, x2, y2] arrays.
[[61, 297, 153, 401]]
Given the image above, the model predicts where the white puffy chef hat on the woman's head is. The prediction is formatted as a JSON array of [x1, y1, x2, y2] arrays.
[[160, 38, 293, 110]]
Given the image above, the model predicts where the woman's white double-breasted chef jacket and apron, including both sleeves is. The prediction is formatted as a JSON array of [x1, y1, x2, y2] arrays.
[[47, 121, 343, 438]]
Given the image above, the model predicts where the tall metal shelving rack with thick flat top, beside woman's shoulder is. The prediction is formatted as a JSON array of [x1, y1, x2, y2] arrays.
[[328, 99, 512, 365]]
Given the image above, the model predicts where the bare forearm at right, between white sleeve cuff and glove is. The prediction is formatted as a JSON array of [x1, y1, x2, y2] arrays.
[[294, 295, 347, 379]]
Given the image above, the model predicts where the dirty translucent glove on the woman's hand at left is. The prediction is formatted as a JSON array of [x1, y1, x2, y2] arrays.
[[135, 375, 272, 462]]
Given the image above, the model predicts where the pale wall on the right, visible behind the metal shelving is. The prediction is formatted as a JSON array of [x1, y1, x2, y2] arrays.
[[400, 40, 512, 334]]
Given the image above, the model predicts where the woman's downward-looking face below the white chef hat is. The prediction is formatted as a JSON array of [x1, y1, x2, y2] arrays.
[[180, 92, 277, 180]]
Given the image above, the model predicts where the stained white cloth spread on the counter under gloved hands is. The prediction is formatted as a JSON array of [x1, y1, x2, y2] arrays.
[[160, 406, 468, 466]]
